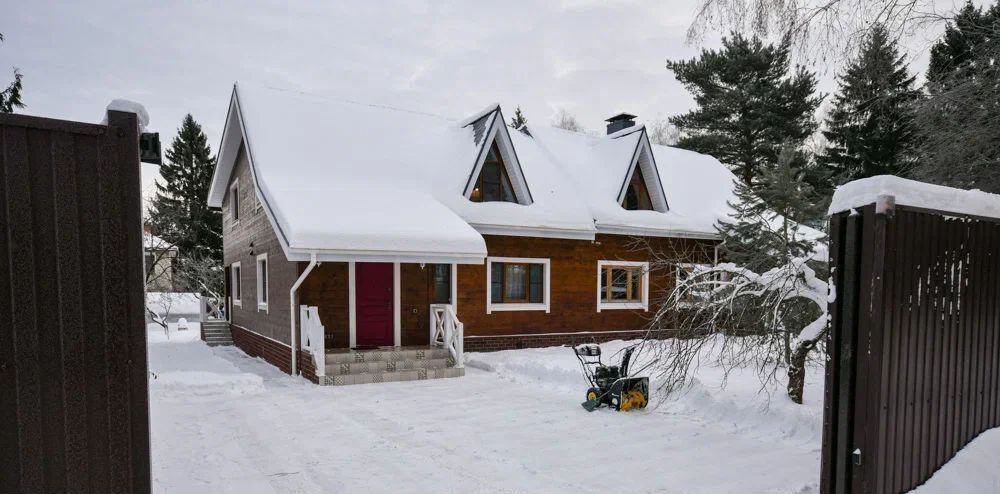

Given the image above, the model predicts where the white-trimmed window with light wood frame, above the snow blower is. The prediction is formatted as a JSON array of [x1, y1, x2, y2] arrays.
[[597, 261, 649, 312]]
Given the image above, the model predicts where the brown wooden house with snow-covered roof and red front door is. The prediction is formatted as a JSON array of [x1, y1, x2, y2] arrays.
[[209, 84, 733, 384]]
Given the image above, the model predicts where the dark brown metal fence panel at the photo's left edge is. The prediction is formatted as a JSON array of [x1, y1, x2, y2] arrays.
[[0, 112, 150, 493]]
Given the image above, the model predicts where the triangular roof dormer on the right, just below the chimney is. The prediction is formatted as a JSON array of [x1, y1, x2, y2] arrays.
[[612, 127, 670, 213]]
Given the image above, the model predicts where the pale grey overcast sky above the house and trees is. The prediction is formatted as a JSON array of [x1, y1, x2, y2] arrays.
[[0, 0, 976, 191]]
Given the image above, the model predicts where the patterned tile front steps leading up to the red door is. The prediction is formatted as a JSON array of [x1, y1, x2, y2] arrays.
[[324, 347, 465, 386]]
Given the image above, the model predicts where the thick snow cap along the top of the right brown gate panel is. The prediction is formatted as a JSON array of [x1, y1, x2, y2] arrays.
[[830, 175, 1000, 218]]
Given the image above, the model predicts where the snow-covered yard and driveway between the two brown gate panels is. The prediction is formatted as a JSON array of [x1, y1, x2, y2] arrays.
[[149, 337, 822, 493]]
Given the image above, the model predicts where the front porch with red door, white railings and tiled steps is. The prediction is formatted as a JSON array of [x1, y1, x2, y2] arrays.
[[297, 262, 465, 385]]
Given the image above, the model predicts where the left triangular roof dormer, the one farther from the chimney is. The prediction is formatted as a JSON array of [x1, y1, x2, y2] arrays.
[[461, 105, 532, 205]]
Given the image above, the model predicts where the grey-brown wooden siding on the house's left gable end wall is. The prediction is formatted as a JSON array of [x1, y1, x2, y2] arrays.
[[222, 143, 301, 344]]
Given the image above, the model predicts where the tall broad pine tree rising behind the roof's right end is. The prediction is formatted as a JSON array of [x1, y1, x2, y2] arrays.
[[667, 33, 822, 186]]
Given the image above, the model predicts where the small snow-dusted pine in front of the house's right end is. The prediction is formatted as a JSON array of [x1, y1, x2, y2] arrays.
[[716, 148, 822, 273]]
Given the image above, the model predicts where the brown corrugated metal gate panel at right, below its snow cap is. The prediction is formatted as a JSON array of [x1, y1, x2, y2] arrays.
[[821, 199, 1000, 493]]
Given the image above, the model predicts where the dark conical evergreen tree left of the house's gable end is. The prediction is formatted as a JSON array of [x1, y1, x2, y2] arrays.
[[150, 114, 222, 263]]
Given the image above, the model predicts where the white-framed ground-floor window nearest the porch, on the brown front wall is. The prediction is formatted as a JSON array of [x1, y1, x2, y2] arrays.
[[486, 257, 551, 314]]
